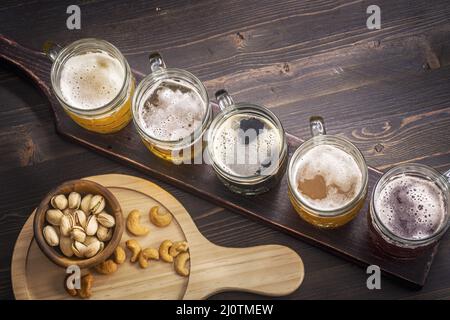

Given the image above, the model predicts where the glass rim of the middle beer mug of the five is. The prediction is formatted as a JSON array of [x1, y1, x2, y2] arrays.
[[207, 90, 287, 185]]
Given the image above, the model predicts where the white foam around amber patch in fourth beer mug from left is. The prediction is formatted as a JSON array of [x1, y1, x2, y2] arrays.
[[296, 145, 362, 210]]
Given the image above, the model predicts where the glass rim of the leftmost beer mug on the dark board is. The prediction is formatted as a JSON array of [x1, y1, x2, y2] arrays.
[[47, 38, 133, 116]]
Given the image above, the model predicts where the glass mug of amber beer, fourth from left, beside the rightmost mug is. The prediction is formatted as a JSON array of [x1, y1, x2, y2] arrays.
[[288, 117, 368, 228]]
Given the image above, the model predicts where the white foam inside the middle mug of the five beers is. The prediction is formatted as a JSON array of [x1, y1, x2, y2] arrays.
[[212, 114, 282, 177]]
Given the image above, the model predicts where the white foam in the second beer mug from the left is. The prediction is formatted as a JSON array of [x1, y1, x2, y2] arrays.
[[139, 81, 206, 141]]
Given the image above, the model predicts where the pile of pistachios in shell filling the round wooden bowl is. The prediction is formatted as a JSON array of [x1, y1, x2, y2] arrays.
[[42, 192, 115, 259]]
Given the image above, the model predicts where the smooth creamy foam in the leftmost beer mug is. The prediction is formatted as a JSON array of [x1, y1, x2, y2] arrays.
[[60, 51, 125, 110]]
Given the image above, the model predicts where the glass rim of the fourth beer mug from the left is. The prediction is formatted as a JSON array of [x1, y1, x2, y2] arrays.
[[288, 130, 369, 218]]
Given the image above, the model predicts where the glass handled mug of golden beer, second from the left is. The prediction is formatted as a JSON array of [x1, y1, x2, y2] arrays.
[[132, 53, 212, 164]]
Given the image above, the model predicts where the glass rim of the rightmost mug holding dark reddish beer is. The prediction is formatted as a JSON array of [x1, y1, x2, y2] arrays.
[[369, 163, 450, 248]]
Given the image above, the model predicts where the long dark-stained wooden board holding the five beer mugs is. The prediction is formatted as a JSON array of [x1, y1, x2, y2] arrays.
[[0, 34, 438, 287]]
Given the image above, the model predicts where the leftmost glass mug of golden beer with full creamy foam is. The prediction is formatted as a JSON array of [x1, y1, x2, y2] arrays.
[[44, 38, 134, 133]]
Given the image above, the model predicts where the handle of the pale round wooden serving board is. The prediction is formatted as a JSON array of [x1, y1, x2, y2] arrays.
[[184, 244, 304, 299]]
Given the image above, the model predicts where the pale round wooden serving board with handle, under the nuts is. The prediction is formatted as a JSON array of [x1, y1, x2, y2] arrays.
[[11, 174, 304, 300]]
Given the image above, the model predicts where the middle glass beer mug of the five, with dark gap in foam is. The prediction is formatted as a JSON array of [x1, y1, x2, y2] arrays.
[[207, 90, 287, 195]]
